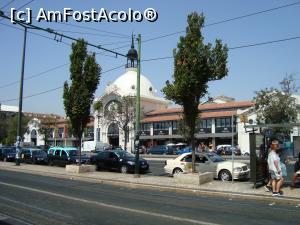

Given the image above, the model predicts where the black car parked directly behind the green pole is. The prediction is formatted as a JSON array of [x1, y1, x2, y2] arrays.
[[94, 150, 149, 173]]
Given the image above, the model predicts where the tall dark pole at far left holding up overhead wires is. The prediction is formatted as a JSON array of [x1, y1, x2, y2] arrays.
[[16, 26, 27, 166]]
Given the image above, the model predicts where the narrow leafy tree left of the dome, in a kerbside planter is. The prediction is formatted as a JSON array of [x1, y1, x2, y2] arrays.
[[63, 39, 101, 164]]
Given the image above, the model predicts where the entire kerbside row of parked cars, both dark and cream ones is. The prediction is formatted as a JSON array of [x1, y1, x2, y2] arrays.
[[0, 147, 250, 180]]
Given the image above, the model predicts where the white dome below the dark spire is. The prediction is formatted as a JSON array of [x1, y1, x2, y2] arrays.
[[112, 68, 155, 98]]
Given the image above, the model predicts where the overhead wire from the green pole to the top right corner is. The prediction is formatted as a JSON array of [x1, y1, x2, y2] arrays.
[[143, 1, 300, 43]]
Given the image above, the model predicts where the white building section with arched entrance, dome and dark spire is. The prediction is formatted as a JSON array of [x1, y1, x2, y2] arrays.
[[93, 38, 170, 151]]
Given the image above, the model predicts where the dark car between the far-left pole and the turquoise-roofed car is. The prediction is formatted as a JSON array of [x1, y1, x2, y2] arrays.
[[21, 148, 48, 164]]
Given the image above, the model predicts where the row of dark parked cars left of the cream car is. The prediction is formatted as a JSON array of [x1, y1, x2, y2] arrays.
[[0, 147, 149, 173]]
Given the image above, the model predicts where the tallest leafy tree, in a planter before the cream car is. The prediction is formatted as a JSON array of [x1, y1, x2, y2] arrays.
[[162, 12, 228, 172]]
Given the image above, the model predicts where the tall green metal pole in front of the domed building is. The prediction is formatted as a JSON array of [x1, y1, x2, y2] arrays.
[[134, 34, 141, 177]]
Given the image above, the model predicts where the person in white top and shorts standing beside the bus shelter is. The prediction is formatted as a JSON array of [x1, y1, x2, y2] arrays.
[[268, 140, 283, 196]]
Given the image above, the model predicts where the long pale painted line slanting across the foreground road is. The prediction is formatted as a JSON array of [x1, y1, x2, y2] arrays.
[[0, 182, 218, 225]]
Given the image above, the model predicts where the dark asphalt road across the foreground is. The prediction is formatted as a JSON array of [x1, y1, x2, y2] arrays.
[[0, 170, 300, 225]]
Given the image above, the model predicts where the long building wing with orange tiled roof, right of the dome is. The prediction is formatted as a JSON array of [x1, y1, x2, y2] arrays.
[[141, 96, 253, 154]]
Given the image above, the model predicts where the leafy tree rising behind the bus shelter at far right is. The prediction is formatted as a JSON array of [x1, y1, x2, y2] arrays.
[[253, 74, 298, 138]]
